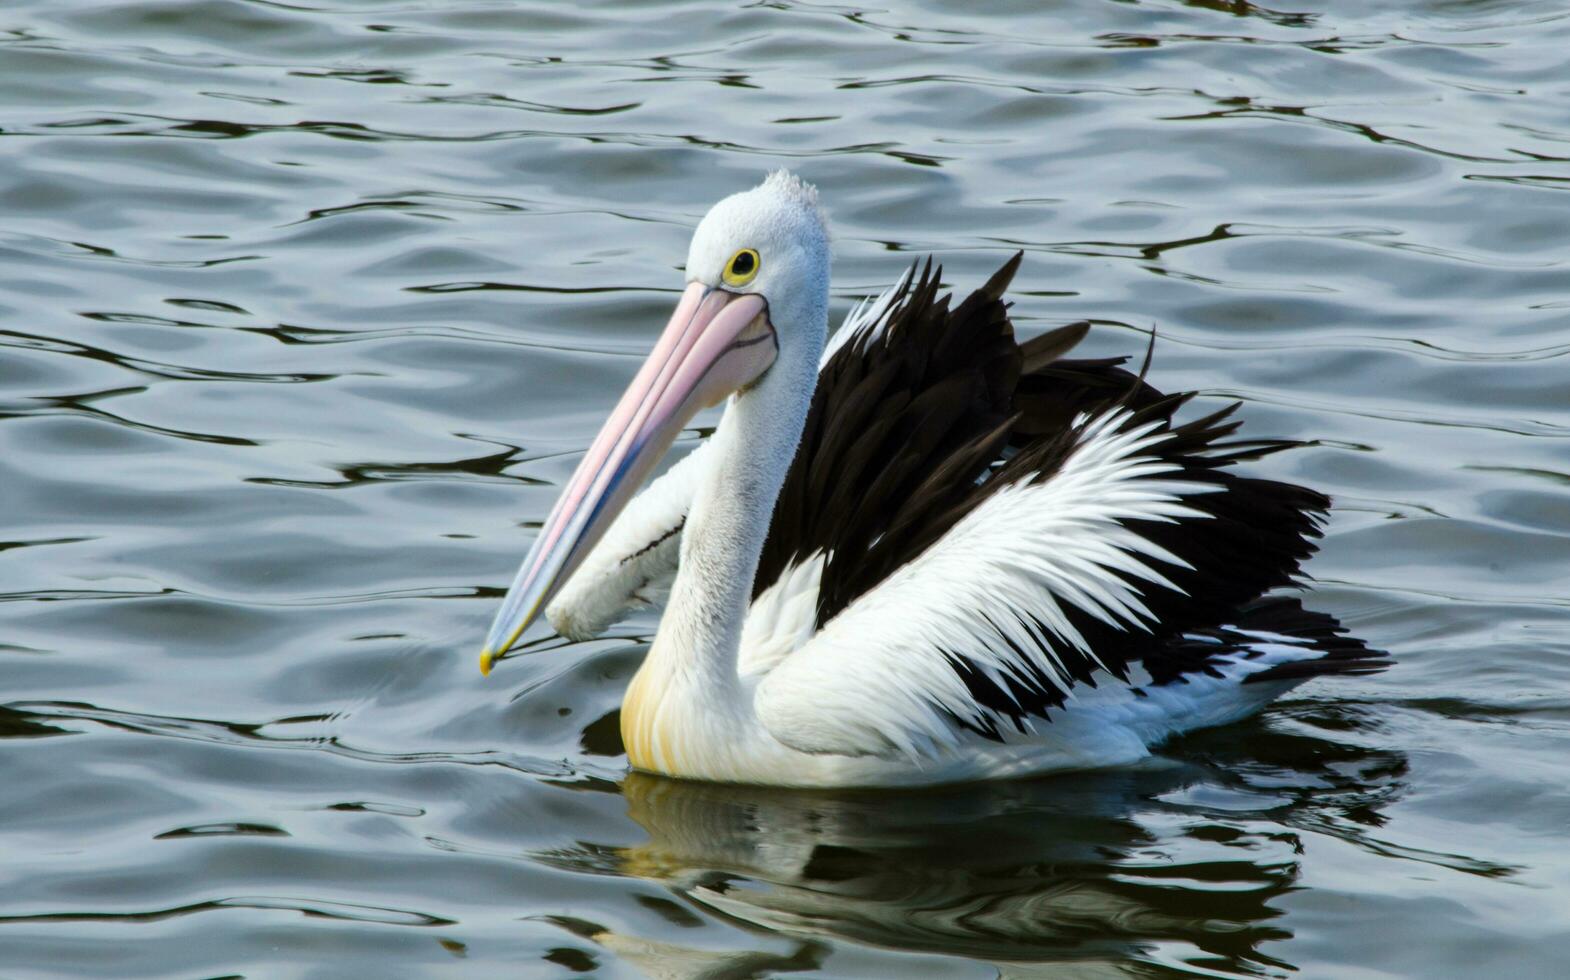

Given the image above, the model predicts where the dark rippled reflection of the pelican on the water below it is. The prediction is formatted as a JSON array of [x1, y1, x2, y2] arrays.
[[551, 716, 1425, 975]]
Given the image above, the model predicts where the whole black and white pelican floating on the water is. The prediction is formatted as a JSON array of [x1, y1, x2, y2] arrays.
[[480, 170, 1391, 788]]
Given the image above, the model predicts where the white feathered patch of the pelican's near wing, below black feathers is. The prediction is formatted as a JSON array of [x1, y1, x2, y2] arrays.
[[755, 410, 1215, 757]]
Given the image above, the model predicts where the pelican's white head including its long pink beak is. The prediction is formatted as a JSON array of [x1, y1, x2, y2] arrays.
[[480, 170, 829, 672]]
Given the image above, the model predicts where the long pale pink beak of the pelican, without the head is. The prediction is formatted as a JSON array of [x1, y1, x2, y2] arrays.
[[480, 283, 779, 674]]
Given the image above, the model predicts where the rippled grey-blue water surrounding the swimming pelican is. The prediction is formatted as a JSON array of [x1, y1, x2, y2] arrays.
[[0, 0, 1570, 977]]
